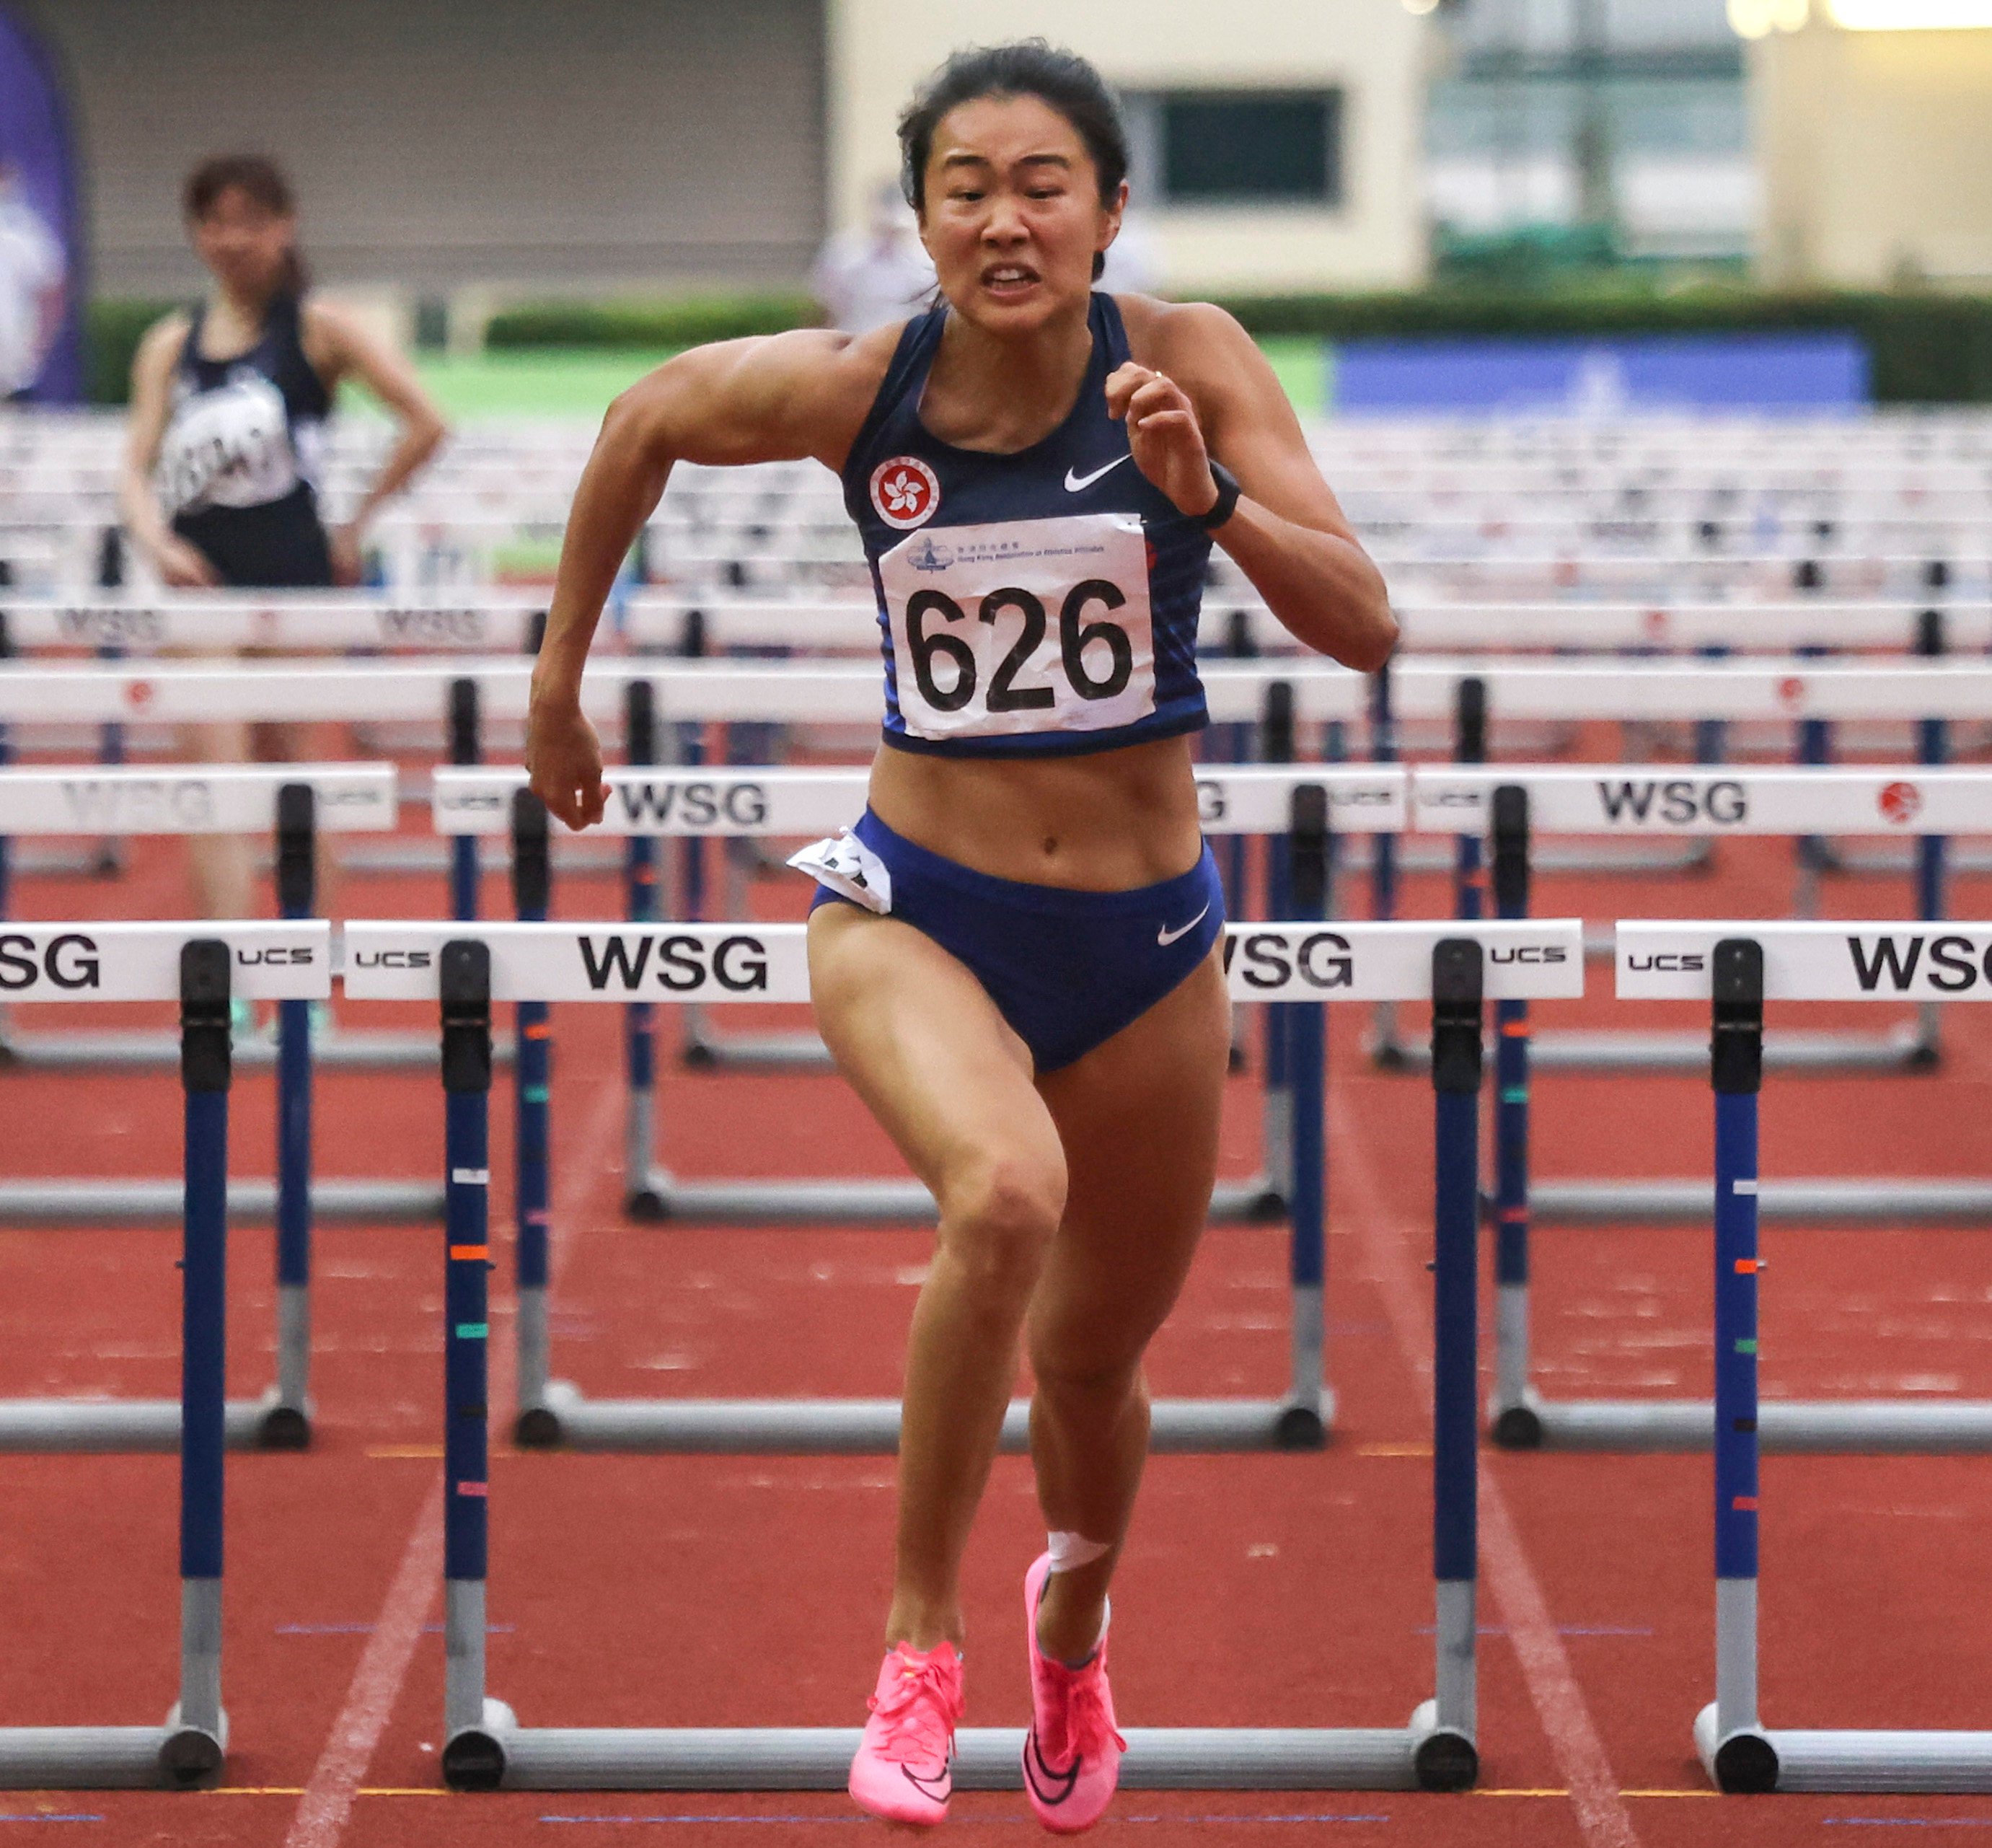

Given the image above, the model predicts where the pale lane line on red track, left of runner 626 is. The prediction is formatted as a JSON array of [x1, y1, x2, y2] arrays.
[[283, 1043, 622, 1848]]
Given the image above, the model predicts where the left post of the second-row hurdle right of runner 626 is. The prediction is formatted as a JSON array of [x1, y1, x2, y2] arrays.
[[1488, 783, 1542, 1450]]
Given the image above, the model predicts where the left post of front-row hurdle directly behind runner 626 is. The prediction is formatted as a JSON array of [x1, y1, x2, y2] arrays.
[[436, 938, 498, 1788]]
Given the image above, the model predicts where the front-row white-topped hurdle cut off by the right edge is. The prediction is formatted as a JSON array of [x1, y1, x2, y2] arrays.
[[1618, 922, 1992, 1792]]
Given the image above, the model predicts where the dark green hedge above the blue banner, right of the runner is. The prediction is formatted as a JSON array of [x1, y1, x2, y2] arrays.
[[1225, 289, 1992, 404]]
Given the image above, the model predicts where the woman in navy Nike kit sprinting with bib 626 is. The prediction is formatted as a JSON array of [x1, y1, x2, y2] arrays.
[[528, 42, 1396, 1832]]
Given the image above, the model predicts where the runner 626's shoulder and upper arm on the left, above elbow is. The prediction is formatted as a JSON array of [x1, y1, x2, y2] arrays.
[[615, 329, 899, 483]]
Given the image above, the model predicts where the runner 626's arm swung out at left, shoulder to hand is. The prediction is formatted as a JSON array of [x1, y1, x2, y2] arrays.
[[526, 329, 876, 828]]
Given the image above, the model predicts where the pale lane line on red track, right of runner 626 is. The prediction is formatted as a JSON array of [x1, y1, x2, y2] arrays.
[[1328, 1083, 1639, 1848]]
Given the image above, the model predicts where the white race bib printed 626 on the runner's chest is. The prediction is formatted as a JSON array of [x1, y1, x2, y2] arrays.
[[878, 514, 1155, 739]]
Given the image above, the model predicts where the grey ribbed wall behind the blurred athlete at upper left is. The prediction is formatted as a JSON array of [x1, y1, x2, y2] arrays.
[[22, 0, 823, 295]]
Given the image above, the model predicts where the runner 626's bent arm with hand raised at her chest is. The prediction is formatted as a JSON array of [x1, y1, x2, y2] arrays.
[[1108, 303, 1396, 673]]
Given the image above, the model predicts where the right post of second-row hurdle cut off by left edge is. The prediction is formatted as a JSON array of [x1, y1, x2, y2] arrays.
[[268, 783, 319, 1450]]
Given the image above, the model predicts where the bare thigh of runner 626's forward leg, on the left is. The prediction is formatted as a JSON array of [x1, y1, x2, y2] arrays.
[[808, 904, 1064, 1197]]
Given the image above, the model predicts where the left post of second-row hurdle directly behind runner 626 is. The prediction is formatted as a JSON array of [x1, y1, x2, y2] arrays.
[[512, 788, 560, 1446]]
